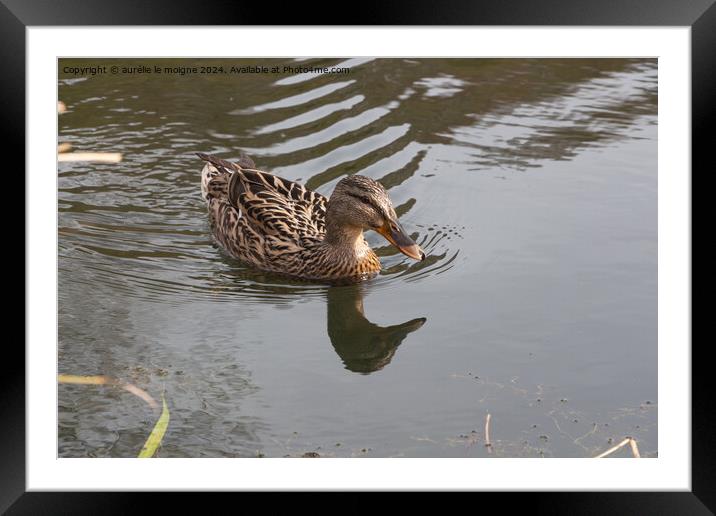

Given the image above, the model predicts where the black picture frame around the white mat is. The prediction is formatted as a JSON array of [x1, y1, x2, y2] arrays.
[[0, 0, 716, 514]]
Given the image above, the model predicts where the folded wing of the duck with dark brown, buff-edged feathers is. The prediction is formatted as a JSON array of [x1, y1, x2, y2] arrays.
[[194, 154, 328, 243]]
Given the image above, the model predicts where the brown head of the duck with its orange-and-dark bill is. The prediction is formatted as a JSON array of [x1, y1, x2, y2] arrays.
[[326, 175, 425, 260]]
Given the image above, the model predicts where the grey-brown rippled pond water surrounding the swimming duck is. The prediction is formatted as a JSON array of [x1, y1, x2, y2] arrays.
[[58, 59, 658, 457]]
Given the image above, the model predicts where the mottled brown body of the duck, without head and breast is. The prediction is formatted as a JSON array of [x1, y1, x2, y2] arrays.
[[198, 154, 327, 275]]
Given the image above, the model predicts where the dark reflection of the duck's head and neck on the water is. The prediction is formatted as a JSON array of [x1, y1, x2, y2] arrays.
[[328, 285, 426, 374]]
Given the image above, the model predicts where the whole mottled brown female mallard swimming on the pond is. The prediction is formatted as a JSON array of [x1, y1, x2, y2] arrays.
[[197, 153, 425, 280]]
